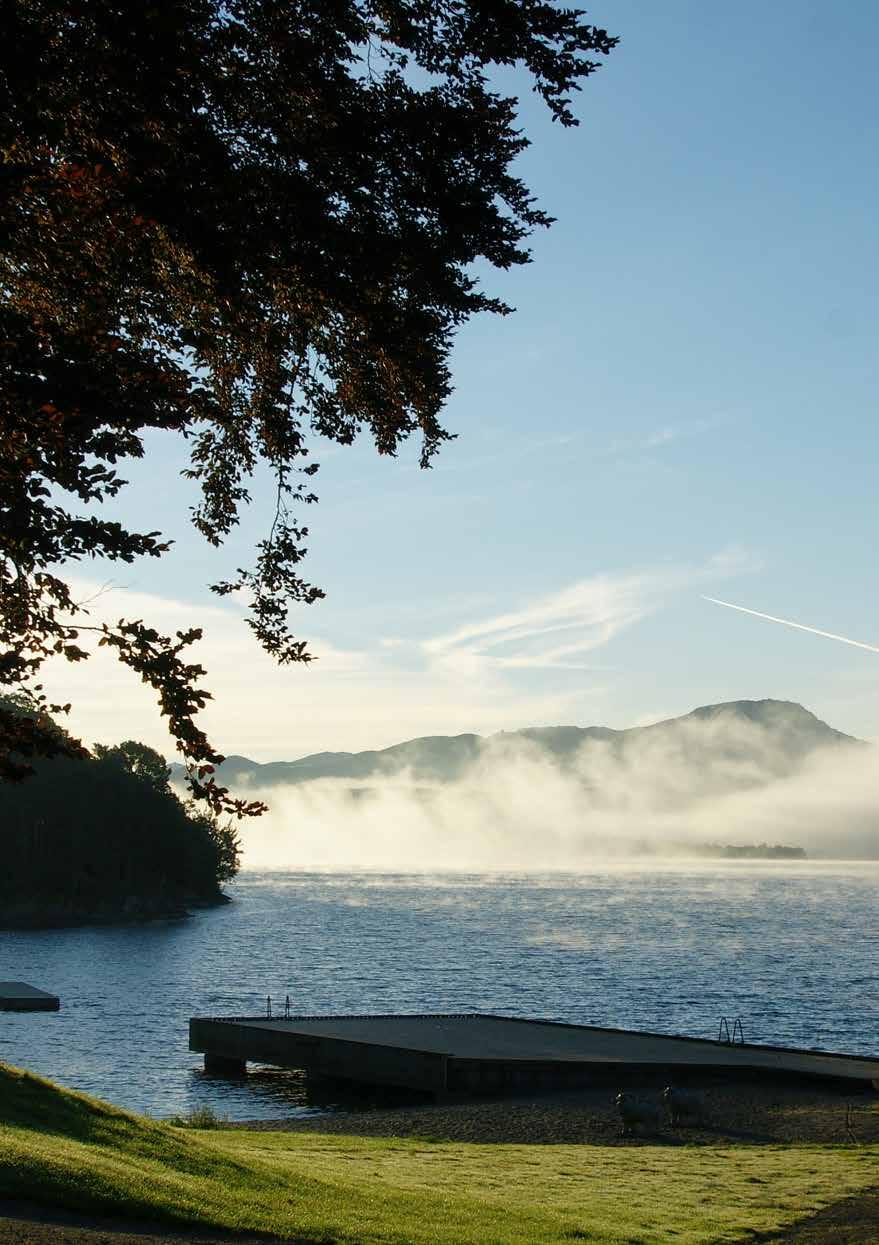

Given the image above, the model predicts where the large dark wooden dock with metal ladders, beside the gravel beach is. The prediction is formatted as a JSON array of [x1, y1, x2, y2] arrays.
[[189, 1013, 879, 1097]]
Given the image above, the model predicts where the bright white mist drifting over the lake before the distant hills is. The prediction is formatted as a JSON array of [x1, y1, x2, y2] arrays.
[[231, 717, 879, 872]]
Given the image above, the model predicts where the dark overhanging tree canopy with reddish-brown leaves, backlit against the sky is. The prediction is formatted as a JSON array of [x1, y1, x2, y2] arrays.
[[0, 0, 616, 812]]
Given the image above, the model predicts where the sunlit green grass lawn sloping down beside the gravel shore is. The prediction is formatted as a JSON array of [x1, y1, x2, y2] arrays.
[[0, 1064, 879, 1245]]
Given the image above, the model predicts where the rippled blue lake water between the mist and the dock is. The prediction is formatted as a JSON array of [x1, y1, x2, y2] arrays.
[[0, 862, 879, 1119]]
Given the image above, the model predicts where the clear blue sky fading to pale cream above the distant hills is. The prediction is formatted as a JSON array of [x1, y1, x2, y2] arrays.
[[45, 0, 879, 761]]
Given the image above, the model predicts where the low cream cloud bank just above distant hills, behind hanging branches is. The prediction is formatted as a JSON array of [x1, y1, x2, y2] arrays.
[[44, 580, 587, 761]]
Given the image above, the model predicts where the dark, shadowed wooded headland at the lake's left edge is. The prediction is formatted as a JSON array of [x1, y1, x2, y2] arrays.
[[0, 702, 238, 928]]
